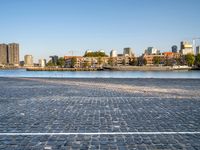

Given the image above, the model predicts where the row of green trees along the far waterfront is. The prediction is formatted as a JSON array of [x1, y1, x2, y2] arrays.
[[47, 52, 200, 68]]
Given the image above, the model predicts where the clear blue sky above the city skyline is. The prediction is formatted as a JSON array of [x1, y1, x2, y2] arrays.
[[0, 0, 200, 62]]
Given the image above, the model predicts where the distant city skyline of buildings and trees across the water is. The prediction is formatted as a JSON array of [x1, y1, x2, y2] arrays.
[[0, 38, 200, 68]]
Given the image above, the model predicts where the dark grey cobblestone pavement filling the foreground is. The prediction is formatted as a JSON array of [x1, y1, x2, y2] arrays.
[[0, 78, 200, 150]]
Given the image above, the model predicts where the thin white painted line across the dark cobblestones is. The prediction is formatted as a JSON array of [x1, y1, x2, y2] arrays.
[[0, 132, 200, 136]]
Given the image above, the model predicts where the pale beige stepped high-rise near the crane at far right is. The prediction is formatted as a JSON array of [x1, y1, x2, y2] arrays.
[[180, 41, 194, 55]]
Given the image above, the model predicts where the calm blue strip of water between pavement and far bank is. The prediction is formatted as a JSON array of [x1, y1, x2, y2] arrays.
[[0, 69, 200, 78]]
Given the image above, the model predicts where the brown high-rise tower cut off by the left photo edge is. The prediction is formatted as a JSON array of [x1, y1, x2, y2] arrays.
[[0, 44, 8, 65]]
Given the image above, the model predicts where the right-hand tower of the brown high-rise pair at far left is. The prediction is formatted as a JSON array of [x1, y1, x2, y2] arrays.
[[8, 43, 19, 66]]
